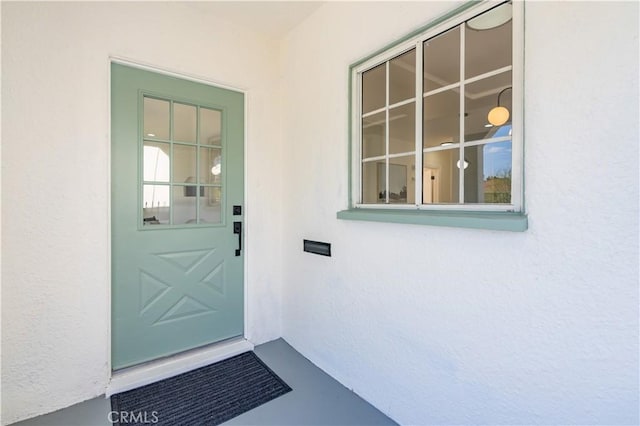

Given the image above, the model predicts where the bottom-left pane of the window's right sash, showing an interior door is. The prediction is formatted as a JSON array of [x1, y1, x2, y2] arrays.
[[422, 148, 464, 204]]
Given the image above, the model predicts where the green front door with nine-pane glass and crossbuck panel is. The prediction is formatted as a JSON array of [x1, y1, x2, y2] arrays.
[[111, 63, 244, 370]]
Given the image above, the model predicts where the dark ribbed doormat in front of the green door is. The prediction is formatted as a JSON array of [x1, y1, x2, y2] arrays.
[[110, 352, 291, 426]]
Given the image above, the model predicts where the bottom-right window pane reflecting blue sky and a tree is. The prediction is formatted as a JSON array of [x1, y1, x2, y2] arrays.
[[464, 141, 511, 204]]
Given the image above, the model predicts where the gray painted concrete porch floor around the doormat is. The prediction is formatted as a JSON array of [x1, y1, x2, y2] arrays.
[[14, 339, 396, 426]]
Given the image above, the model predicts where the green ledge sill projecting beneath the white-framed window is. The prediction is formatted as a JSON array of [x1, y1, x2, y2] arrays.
[[337, 208, 528, 232]]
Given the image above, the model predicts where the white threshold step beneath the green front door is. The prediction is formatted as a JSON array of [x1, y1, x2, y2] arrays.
[[105, 337, 253, 398]]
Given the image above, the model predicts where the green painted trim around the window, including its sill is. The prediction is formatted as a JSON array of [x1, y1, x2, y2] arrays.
[[336, 0, 529, 232]]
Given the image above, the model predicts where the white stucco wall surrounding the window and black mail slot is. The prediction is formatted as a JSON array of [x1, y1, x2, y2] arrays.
[[281, 2, 639, 425]]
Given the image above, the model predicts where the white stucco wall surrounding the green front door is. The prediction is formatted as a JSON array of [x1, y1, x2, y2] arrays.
[[2, 2, 282, 424]]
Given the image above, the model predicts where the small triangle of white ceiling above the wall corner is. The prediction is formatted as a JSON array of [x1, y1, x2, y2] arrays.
[[184, 1, 325, 38]]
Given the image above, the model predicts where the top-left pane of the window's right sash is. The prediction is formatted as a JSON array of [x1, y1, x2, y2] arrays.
[[423, 27, 460, 93]]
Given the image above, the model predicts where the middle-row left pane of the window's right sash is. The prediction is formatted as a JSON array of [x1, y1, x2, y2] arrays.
[[423, 90, 460, 148]]
